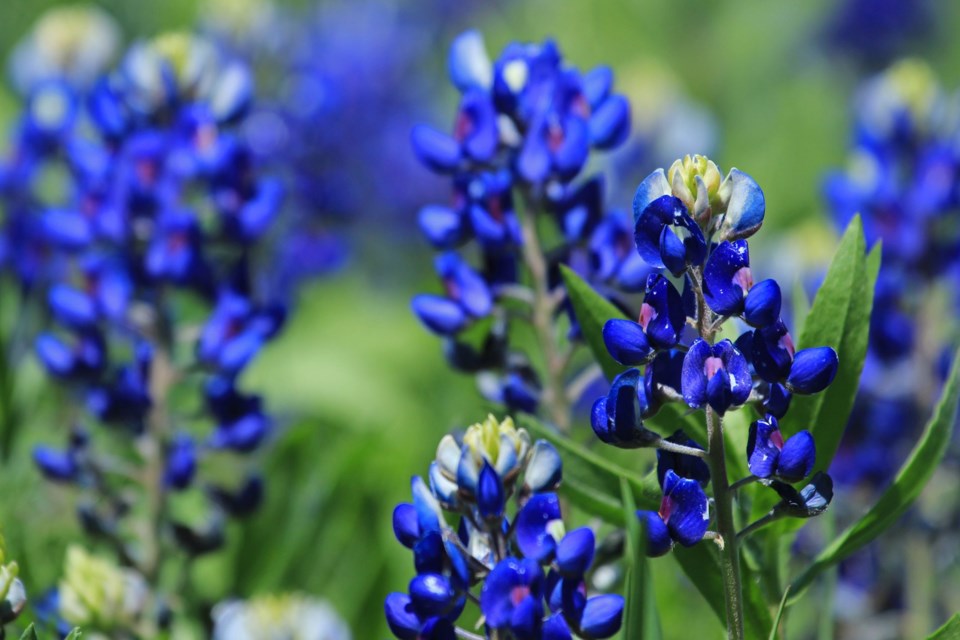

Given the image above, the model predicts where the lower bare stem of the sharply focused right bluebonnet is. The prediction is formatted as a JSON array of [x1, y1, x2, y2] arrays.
[[707, 407, 744, 640]]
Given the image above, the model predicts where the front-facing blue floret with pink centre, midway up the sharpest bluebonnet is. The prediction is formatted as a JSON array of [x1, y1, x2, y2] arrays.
[[682, 339, 753, 413]]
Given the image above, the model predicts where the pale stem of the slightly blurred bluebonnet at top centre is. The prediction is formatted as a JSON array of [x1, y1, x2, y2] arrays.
[[521, 199, 570, 433]]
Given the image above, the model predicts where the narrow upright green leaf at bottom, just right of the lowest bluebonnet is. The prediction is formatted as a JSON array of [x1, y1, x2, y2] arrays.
[[620, 478, 662, 640]]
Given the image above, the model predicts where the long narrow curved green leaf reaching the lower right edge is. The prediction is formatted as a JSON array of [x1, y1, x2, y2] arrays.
[[792, 351, 960, 600]]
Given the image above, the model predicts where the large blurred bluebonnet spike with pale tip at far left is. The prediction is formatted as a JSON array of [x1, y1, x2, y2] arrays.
[[0, 25, 286, 632]]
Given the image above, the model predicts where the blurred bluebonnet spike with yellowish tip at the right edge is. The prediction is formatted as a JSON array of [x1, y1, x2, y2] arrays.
[[824, 60, 960, 486]]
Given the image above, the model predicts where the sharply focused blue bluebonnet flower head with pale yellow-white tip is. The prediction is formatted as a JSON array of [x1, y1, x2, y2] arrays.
[[591, 156, 838, 555]]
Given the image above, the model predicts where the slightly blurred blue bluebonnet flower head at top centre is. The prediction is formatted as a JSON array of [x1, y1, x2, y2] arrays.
[[412, 32, 649, 427]]
